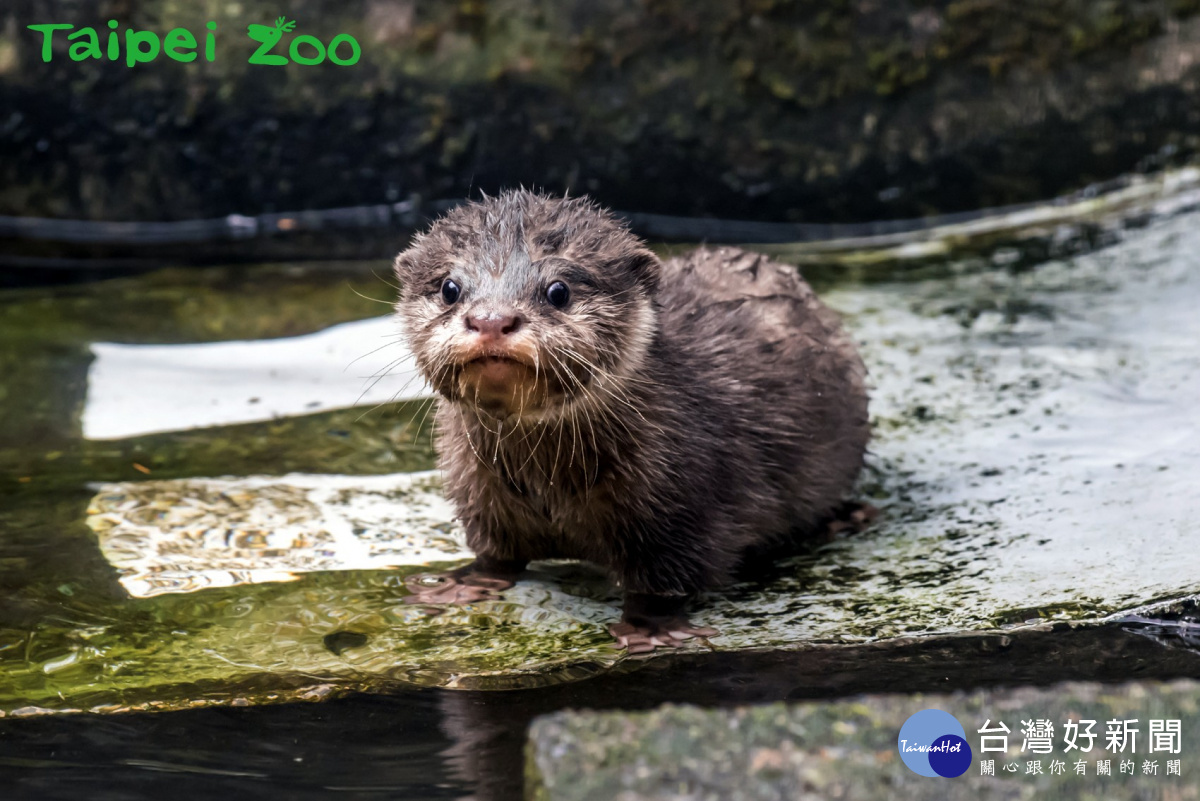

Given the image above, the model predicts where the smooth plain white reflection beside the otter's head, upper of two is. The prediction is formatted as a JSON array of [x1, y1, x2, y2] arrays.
[[83, 317, 427, 439]]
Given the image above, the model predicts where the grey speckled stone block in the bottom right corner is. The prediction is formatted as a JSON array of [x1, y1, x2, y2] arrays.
[[527, 681, 1200, 801]]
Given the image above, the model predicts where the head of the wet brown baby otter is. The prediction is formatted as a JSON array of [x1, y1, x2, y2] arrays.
[[395, 191, 661, 420]]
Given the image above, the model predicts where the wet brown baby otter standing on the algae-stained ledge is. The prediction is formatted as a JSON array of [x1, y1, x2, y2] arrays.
[[395, 191, 868, 652]]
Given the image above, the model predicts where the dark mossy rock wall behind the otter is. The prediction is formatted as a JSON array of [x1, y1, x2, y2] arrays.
[[0, 0, 1200, 222]]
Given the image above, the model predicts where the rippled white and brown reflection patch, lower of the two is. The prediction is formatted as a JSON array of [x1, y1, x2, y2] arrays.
[[88, 472, 470, 598]]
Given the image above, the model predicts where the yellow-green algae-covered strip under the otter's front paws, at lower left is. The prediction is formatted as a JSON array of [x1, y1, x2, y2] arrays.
[[0, 562, 617, 715]]
